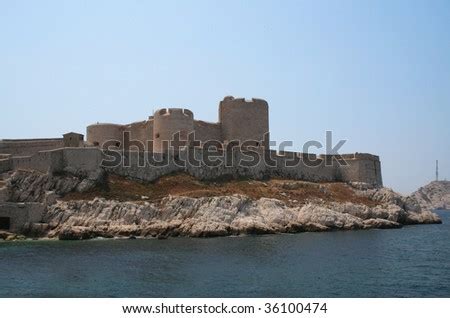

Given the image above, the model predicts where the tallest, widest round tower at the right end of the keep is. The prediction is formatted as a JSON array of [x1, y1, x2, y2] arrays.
[[219, 96, 269, 148]]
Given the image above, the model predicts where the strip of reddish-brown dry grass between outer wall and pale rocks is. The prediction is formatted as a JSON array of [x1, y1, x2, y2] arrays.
[[64, 174, 376, 206]]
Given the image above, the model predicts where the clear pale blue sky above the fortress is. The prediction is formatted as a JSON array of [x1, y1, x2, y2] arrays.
[[0, 0, 450, 193]]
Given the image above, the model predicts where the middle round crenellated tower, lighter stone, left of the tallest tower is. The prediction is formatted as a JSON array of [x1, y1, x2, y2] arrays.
[[153, 108, 194, 153]]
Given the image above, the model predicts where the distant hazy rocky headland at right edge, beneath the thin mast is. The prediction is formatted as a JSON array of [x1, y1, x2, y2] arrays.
[[411, 181, 450, 210]]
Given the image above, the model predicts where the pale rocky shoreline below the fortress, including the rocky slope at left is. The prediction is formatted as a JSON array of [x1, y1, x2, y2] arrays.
[[0, 172, 441, 240]]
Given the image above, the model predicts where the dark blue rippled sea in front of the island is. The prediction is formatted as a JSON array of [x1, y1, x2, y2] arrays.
[[0, 211, 450, 297]]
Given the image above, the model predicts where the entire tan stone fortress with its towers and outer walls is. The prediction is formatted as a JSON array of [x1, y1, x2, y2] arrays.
[[0, 96, 382, 186]]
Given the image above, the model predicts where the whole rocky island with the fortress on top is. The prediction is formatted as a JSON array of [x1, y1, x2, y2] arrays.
[[0, 96, 441, 240]]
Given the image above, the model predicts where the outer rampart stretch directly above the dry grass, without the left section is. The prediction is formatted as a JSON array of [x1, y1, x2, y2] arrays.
[[104, 149, 370, 184]]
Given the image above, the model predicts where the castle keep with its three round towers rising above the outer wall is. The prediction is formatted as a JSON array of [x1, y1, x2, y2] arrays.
[[86, 96, 269, 153]]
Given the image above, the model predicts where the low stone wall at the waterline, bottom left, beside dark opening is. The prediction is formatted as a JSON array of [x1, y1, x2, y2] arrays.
[[0, 202, 44, 232]]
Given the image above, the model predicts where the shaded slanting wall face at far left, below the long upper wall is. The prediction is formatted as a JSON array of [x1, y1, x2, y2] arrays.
[[11, 148, 64, 173]]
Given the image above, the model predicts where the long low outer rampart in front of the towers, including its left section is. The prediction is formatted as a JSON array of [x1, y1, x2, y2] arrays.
[[2, 148, 382, 185]]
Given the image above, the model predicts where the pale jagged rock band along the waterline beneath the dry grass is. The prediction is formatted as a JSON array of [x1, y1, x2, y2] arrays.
[[44, 193, 440, 239]]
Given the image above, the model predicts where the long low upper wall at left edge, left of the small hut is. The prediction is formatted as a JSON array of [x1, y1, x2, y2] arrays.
[[0, 138, 64, 156]]
